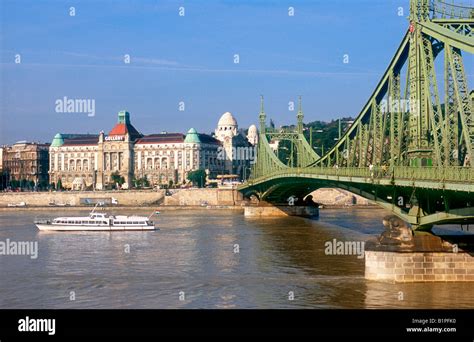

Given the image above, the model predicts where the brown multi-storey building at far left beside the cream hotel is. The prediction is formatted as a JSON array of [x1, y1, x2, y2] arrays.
[[0, 141, 49, 187]]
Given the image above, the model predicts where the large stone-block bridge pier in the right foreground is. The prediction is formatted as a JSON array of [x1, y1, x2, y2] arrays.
[[365, 216, 474, 283]]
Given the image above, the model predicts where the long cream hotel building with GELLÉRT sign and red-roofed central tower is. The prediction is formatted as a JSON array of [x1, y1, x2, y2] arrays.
[[49, 111, 224, 190]]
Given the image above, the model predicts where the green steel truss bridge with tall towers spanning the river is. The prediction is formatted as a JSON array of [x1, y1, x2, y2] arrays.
[[238, 0, 474, 230]]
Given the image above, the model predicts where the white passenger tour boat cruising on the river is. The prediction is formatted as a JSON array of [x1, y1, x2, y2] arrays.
[[35, 206, 155, 231]]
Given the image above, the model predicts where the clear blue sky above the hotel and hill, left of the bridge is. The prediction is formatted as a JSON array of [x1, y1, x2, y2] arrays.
[[0, 0, 426, 144]]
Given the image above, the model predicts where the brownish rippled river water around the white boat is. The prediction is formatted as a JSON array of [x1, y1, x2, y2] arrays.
[[0, 209, 474, 309]]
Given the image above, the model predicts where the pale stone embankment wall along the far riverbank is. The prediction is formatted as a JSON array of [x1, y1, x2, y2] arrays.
[[0, 188, 378, 211]]
